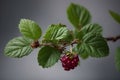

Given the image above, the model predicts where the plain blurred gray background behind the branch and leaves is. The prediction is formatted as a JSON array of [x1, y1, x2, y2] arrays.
[[0, 0, 120, 80]]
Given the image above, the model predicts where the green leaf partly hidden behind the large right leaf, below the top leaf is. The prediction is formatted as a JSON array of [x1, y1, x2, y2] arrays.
[[75, 24, 102, 39]]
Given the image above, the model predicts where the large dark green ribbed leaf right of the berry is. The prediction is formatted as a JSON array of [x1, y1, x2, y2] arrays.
[[77, 33, 109, 57]]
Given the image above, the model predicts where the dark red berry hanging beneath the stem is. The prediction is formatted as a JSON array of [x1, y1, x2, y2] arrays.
[[60, 54, 79, 71]]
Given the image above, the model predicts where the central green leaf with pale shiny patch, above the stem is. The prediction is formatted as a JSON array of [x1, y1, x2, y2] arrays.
[[44, 24, 68, 41]]
